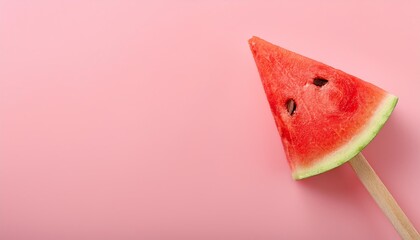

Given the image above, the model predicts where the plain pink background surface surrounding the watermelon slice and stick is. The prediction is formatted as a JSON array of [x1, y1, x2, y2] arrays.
[[0, 0, 420, 240]]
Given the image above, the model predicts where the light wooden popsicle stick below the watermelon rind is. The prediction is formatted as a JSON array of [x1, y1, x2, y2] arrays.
[[349, 153, 420, 240]]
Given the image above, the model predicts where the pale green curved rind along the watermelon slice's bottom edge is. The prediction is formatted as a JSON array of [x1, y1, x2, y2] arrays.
[[292, 94, 398, 180]]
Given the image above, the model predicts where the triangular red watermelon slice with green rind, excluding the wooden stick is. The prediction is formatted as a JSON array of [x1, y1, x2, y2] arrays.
[[249, 37, 398, 179]]
